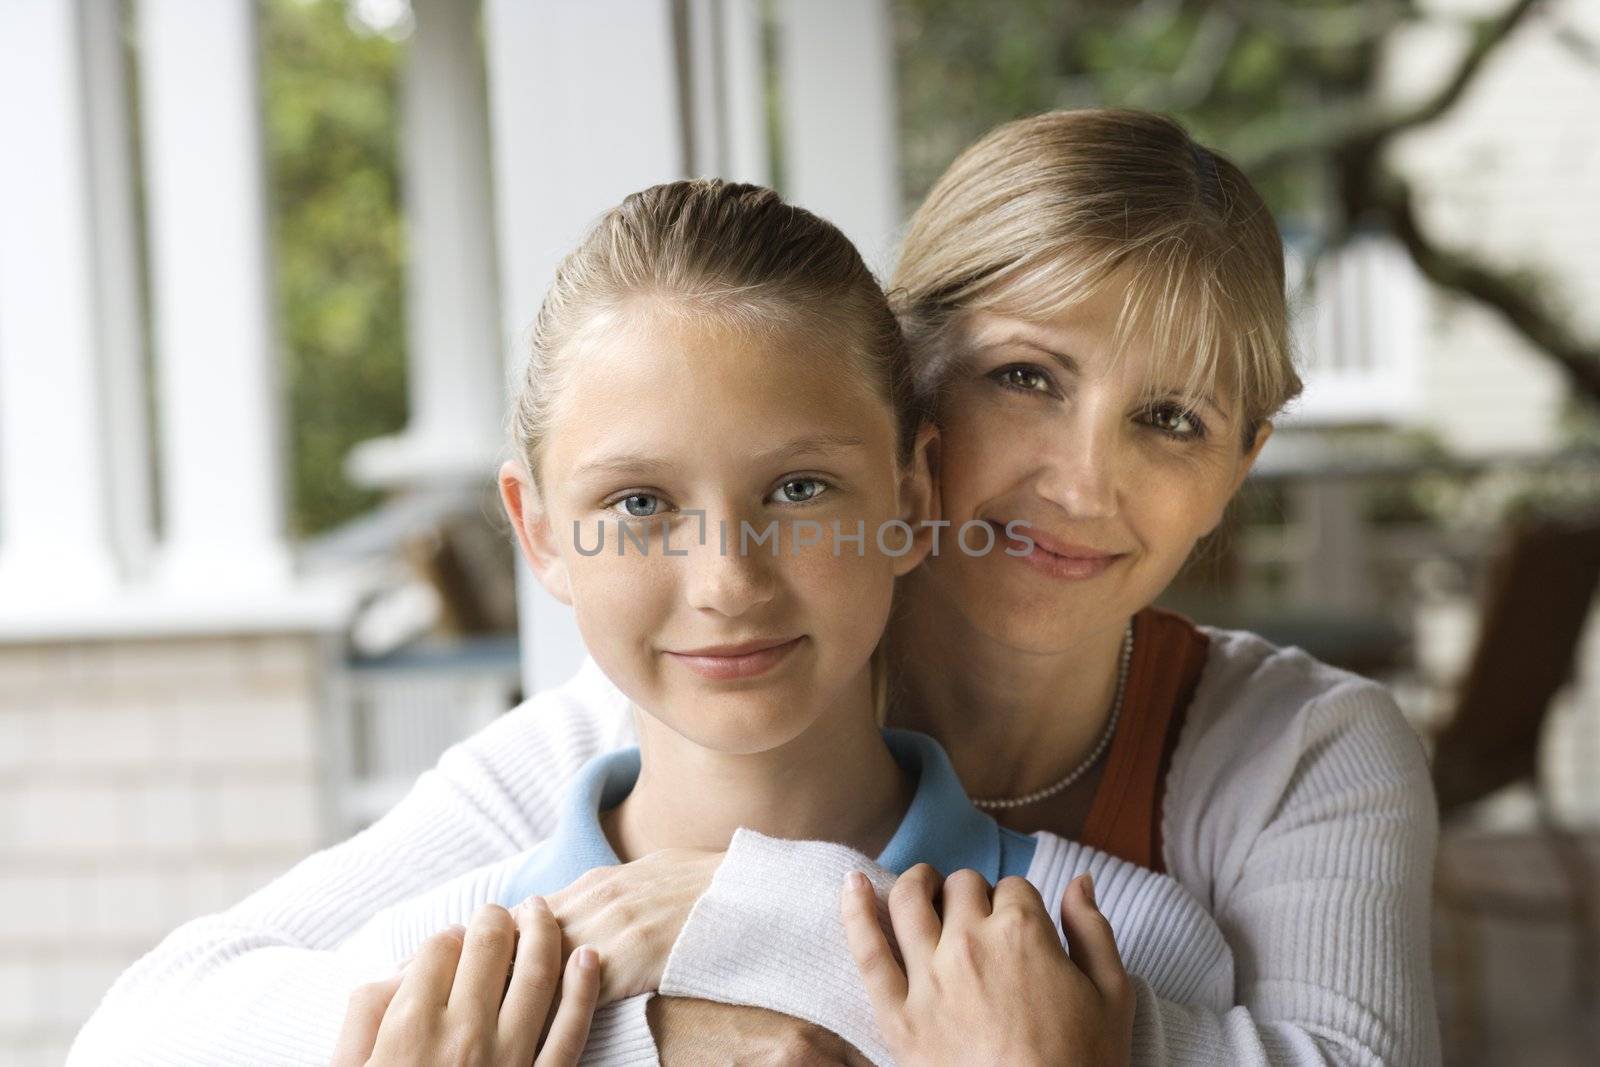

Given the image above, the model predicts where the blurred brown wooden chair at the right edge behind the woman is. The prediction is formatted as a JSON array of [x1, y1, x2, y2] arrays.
[[1434, 520, 1600, 1064]]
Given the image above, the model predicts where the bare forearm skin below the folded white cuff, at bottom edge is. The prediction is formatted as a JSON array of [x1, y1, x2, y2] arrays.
[[646, 997, 872, 1067]]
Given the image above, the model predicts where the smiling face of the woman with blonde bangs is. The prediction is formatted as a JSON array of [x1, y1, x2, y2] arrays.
[[922, 278, 1270, 653]]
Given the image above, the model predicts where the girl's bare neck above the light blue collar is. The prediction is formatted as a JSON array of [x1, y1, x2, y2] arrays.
[[602, 670, 915, 862]]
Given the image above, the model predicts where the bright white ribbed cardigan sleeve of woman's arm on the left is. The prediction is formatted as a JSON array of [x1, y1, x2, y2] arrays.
[[67, 661, 630, 1067]]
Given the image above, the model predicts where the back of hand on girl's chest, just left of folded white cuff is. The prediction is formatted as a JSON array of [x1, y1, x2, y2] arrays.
[[544, 848, 722, 1005]]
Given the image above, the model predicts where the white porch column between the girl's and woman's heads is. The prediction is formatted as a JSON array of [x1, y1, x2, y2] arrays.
[[778, 0, 901, 272]]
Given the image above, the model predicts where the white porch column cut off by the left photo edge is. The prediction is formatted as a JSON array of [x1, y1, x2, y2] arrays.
[[0, 0, 138, 601]]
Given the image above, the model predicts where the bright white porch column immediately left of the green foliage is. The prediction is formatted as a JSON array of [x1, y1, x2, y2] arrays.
[[136, 0, 288, 597]]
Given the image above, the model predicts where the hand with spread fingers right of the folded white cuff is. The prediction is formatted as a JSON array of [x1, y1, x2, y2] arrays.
[[842, 864, 1134, 1065]]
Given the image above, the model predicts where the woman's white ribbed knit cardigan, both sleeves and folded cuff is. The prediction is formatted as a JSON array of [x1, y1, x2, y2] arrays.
[[67, 629, 1438, 1067]]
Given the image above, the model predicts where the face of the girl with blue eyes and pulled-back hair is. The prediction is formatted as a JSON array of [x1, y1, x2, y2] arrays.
[[501, 309, 933, 753]]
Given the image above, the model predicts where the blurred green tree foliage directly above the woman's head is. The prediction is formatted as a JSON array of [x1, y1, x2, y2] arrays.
[[894, 0, 1324, 218]]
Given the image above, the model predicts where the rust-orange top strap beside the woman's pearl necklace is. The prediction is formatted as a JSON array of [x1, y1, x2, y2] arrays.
[[1078, 608, 1211, 872]]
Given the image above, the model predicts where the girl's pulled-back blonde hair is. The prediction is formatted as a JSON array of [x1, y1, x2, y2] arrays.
[[510, 179, 923, 723]]
